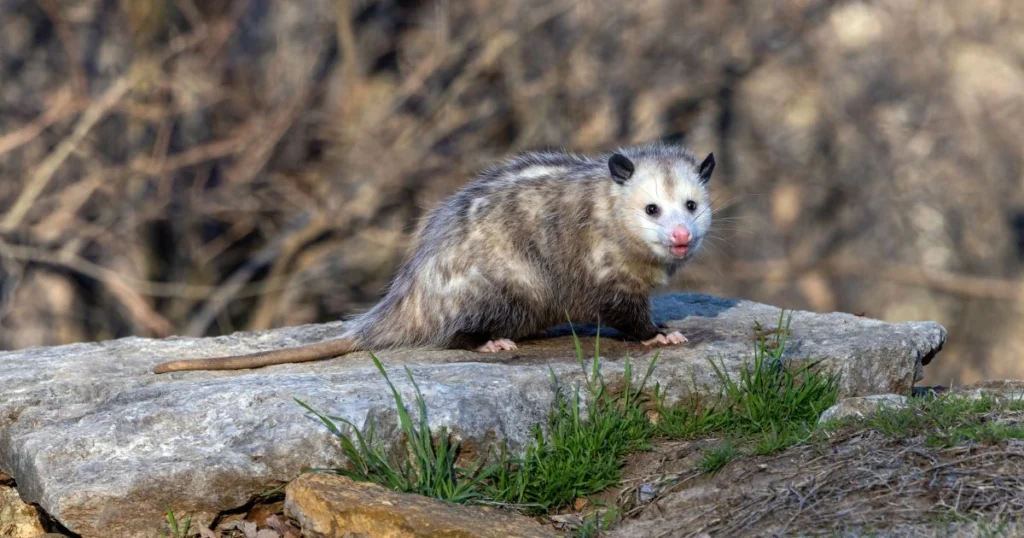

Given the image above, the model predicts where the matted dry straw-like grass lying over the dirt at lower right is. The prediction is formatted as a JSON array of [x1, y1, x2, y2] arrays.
[[707, 433, 1024, 536]]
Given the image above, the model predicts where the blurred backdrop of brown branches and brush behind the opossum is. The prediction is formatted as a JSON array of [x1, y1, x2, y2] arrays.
[[0, 0, 1024, 384]]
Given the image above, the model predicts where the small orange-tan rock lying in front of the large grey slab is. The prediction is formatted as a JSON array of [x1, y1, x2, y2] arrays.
[[285, 474, 560, 538]]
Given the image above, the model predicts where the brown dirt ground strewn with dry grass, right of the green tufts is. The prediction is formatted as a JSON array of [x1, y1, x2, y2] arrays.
[[602, 418, 1024, 538]]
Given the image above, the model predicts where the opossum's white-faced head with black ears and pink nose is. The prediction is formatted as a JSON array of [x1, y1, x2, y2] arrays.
[[608, 148, 715, 262]]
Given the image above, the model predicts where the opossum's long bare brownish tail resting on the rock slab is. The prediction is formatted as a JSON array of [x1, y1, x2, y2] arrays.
[[153, 337, 362, 374]]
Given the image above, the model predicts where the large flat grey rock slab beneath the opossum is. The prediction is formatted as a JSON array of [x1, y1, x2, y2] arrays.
[[0, 294, 946, 537]]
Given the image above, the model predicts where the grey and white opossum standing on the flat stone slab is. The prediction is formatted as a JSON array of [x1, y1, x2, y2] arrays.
[[155, 143, 715, 373]]
